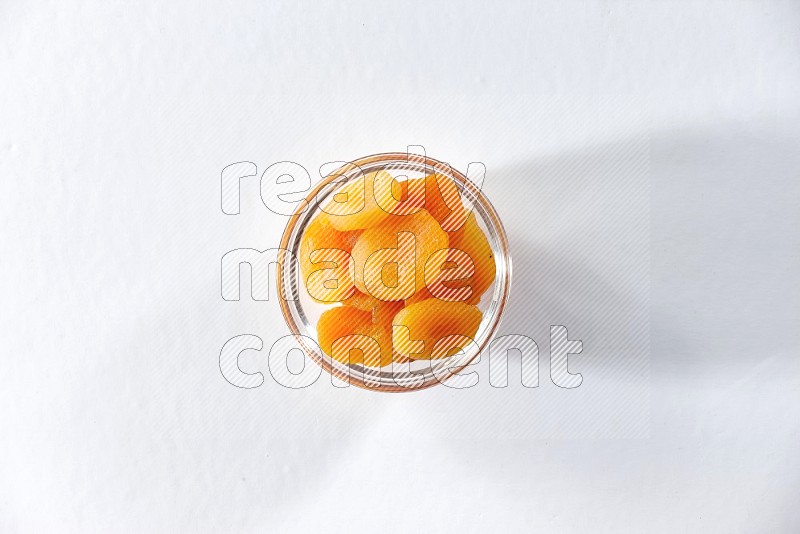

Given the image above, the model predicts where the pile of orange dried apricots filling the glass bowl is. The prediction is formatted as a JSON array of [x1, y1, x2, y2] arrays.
[[298, 171, 495, 367]]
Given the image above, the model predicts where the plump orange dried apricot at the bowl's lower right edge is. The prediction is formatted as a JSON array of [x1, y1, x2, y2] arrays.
[[392, 298, 483, 360]]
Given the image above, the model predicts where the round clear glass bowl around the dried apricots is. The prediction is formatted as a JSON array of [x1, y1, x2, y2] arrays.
[[277, 152, 511, 392]]
